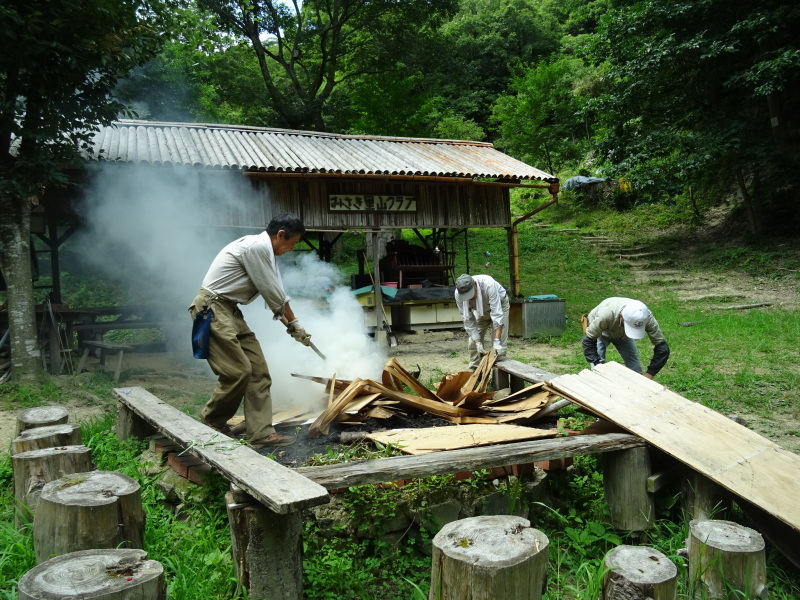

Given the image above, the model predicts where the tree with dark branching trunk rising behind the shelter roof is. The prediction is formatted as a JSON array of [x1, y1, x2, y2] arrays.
[[199, 0, 452, 130]]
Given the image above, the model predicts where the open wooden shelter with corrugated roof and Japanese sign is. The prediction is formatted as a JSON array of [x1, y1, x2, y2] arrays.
[[20, 120, 559, 366]]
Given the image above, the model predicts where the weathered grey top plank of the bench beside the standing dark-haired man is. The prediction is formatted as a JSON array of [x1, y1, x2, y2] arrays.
[[114, 387, 330, 514]]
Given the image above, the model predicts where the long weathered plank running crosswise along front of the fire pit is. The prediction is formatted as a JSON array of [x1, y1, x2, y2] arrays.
[[295, 434, 644, 490]]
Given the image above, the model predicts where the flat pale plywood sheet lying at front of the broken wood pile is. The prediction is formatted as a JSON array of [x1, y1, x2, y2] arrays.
[[367, 425, 558, 454]]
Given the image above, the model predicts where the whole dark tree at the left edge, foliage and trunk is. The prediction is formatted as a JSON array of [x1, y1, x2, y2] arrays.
[[0, 0, 166, 379]]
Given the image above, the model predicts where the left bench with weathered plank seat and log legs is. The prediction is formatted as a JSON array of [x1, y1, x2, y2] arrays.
[[114, 387, 330, 600]]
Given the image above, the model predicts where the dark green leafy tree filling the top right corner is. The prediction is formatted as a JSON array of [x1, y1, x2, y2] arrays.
[[593, 0, 800, 234]]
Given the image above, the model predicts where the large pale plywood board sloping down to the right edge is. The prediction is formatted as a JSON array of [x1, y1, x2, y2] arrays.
[[547, 363, 800, 530]]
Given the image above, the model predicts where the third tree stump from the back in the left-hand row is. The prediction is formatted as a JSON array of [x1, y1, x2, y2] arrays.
[[11, 446, 95, 527]]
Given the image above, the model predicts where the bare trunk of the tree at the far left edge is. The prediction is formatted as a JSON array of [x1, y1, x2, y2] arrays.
[[0, 194, 43, 382]]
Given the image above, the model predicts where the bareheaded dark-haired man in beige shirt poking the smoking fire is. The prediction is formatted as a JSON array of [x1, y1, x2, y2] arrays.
[[189, 213, 311, 448]]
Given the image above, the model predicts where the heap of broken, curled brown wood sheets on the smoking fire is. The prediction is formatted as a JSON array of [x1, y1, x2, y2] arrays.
[[295, 351, 559, 437]]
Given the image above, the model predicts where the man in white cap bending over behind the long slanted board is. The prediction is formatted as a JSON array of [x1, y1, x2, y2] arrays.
[[582, 297, 669, 379]]
